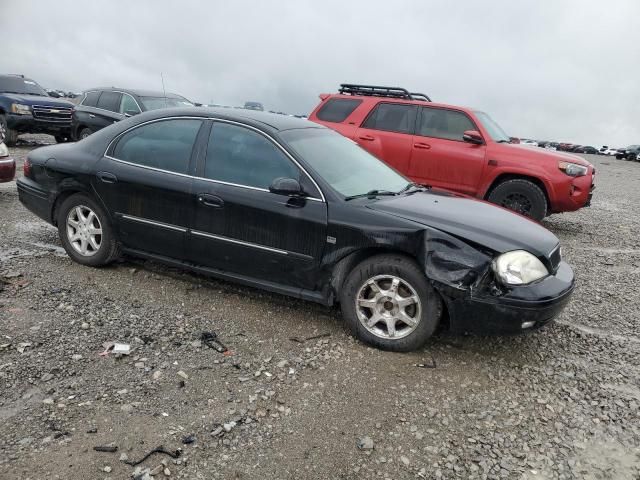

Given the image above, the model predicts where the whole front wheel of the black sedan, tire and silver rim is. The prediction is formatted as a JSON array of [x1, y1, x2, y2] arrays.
[[340, 255, 442, 352]]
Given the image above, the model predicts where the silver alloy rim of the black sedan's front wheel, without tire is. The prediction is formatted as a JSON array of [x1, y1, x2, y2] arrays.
[[355, 275, 422, 340]]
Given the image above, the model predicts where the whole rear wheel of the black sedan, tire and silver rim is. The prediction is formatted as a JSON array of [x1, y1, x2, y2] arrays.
[[57, 193, 120, 267]]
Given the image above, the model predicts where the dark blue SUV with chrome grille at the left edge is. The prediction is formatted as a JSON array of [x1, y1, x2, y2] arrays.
[[0, 75, 73, 147]]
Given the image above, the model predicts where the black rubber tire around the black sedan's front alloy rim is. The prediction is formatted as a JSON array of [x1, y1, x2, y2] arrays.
[[340, 254, 442, 352]]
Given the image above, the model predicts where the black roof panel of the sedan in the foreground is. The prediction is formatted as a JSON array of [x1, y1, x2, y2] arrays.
[[131, 107, 326, 132]]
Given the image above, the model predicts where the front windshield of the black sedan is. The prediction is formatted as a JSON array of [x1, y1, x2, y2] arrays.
[[282, 128, 411, 197]]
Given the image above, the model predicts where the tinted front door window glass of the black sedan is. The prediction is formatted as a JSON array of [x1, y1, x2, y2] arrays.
[[204, 122, 300, 189]]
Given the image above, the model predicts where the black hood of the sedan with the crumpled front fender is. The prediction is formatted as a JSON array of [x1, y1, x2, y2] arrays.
[[367, 191, 559, 257]]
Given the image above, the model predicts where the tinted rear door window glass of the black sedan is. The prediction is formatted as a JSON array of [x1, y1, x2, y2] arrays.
[[112, 118, 202, 174]]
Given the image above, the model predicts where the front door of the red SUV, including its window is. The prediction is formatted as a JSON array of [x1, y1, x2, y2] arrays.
[[408, 106, 486, 196]]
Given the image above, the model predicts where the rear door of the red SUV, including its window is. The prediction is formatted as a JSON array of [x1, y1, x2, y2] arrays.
[[354, 102, 418, 174]]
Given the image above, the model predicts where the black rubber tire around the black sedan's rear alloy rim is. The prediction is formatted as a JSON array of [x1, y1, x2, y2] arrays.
[[57, 193, 120, 267]]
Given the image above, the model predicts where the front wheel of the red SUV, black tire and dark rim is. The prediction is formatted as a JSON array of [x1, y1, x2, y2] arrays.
[[487, 178, 547, 222]]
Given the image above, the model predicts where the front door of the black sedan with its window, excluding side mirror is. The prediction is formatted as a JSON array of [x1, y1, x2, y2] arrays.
[[188, 121, 327, 289]]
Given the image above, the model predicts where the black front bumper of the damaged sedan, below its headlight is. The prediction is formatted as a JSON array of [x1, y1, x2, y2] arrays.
[[438, 262, 575, 334]]
